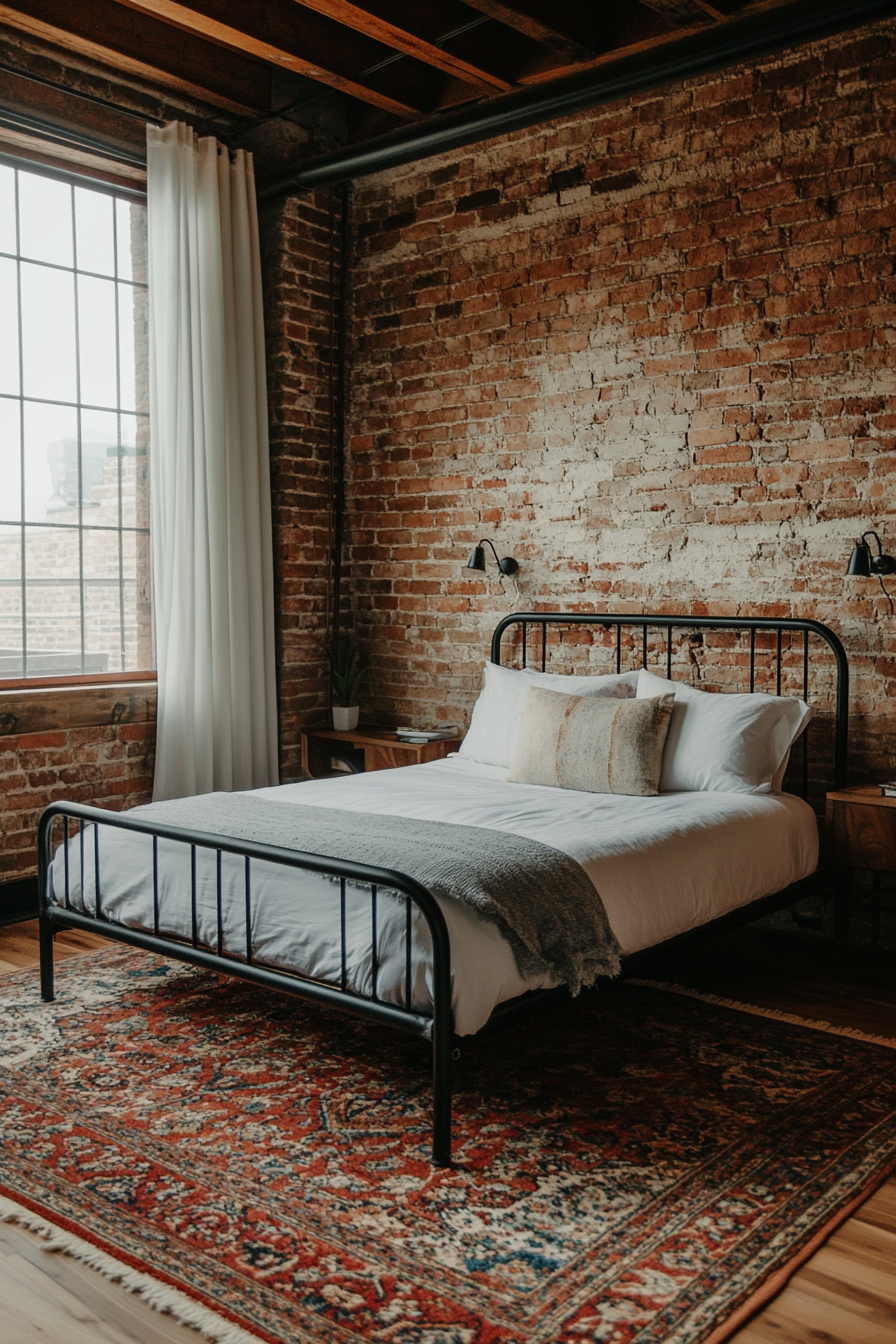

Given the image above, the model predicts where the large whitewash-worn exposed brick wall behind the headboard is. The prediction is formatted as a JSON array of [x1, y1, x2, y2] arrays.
[[349, 22, 896, 778]]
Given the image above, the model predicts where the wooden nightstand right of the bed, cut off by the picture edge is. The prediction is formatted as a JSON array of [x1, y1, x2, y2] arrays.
[[825, 784, 896, 957]]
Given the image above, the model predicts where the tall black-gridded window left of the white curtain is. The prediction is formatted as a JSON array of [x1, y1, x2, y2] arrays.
[[0, 164, 152, 679]]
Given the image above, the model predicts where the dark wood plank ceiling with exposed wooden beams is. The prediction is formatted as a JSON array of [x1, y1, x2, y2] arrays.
[[0, 0, 832, 162]]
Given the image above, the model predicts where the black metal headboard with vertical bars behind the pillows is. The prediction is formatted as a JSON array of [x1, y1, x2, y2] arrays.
[[492, 612, 849, 797]]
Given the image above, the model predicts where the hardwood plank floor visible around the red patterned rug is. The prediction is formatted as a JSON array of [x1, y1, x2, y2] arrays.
[[0, 925, 896, 1344]]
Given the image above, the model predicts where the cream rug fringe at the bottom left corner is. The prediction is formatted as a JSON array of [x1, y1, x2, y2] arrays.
[[0, 1195, 261, 1344]]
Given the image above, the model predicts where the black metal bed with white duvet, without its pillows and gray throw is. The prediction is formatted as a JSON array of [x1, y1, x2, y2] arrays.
[[39, 613, 848, 1165]]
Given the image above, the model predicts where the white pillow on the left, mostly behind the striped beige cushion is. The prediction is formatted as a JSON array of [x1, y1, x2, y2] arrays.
[[458, 663, 638, 769]]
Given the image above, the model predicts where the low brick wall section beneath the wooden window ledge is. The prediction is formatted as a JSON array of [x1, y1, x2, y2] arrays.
[[0, 725, 156, 883]]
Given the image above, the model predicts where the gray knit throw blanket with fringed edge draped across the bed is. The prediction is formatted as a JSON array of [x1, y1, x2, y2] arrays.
[[133, 793, 619, 995]]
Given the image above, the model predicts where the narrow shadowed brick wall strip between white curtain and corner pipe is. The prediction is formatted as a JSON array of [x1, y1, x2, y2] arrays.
[[261, 190, 340, 781]]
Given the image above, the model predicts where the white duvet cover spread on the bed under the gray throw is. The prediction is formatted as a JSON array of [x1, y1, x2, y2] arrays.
[[51, 757, 818, 1035]]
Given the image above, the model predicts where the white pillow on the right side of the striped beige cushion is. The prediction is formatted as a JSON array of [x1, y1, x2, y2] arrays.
[[637, 668, 814, 793]]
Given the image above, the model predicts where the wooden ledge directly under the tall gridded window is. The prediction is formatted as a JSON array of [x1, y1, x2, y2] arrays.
[[0, 672, 156, 738]]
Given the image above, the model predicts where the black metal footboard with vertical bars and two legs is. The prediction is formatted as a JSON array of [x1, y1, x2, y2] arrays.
[[38, 802, 454, 1167]]
